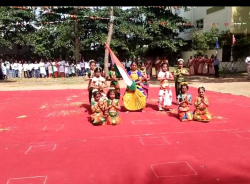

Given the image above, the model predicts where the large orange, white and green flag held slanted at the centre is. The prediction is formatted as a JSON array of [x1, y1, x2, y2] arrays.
[[105, 43, 136, 88]]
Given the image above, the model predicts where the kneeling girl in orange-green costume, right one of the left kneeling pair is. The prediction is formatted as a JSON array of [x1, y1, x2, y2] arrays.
[[105, 88, 121, 125]]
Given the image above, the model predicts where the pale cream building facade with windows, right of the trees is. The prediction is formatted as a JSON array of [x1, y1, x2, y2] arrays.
[[178, 6, 250, 40]]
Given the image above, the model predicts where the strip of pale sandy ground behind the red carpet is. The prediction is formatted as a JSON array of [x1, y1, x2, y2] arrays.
[[0, 74, 250, 97]]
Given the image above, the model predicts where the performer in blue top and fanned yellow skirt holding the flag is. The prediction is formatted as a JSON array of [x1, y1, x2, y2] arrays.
[[123, 61, 146, 112]]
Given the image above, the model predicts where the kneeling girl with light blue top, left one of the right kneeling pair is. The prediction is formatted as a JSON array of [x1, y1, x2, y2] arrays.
[[177, 82, 193, 121]]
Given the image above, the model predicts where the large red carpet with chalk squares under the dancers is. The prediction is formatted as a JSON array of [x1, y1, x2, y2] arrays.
[[0, 88, 250, 184]]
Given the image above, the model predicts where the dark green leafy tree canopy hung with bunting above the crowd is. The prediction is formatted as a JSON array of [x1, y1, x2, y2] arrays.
[[0, 6, 191, 58]]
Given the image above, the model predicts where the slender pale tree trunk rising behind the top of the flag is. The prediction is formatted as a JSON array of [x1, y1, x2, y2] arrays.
[[104, 6, 114, 74]]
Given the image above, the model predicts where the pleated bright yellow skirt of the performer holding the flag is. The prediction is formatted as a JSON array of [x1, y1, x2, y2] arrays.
[[123, 88, 146, 111]]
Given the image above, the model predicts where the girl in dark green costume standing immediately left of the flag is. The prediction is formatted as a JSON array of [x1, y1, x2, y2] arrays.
[[107, 65, 120, 99]]
